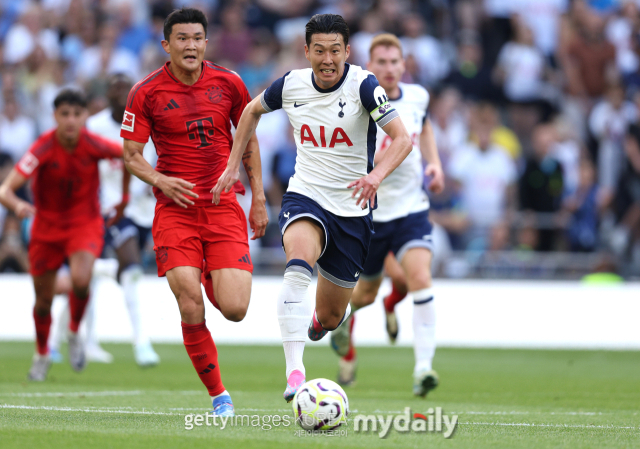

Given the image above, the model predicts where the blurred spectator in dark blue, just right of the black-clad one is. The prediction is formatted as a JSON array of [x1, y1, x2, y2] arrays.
[[564, 157, 599, 251]]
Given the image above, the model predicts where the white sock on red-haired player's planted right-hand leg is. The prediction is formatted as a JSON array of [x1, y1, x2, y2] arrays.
[[411, 288, 436, 373]]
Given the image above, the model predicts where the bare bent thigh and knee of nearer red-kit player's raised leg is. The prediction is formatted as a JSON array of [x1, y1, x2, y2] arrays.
[[211, 268, 251, 321]]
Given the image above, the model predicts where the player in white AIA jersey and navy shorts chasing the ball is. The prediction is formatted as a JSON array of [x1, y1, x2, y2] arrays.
[[212, 14, 411, 401]]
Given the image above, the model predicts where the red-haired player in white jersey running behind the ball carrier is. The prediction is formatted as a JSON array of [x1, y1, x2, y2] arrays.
[[331, 34, 444, 396]]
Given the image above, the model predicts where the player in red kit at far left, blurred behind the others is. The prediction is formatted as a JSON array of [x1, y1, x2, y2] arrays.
[[0, 89, 126, 381]]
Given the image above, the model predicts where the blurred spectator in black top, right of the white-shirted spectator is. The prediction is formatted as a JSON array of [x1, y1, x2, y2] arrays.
[[520, 123, 563, 251]]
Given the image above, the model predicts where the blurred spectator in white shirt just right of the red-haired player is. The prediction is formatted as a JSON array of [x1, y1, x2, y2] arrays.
[[448, 111, 517, 245]]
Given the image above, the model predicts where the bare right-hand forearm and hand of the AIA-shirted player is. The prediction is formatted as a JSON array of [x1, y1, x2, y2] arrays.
[[348, 117, 413, 209]]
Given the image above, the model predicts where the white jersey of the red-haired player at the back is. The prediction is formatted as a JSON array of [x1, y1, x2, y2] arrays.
[[373, 83, 429, 222]]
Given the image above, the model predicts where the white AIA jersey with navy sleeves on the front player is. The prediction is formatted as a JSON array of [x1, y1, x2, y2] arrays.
[[260, 64, 398, 217]]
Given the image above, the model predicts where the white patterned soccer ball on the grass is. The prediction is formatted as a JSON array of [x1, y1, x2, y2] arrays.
[[293, 379, 349, 430]]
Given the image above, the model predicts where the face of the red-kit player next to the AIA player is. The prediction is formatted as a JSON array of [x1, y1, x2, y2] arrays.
[[162, 23, 208, 72]]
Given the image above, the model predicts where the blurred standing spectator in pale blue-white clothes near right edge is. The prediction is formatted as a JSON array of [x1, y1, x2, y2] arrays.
[[589, 84, 638, 200]]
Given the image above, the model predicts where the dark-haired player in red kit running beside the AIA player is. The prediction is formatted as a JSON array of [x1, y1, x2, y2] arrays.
[[121, 8, 268, 416]]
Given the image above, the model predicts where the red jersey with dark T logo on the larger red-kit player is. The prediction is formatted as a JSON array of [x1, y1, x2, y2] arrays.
[[120, 61, 251, 206]]
